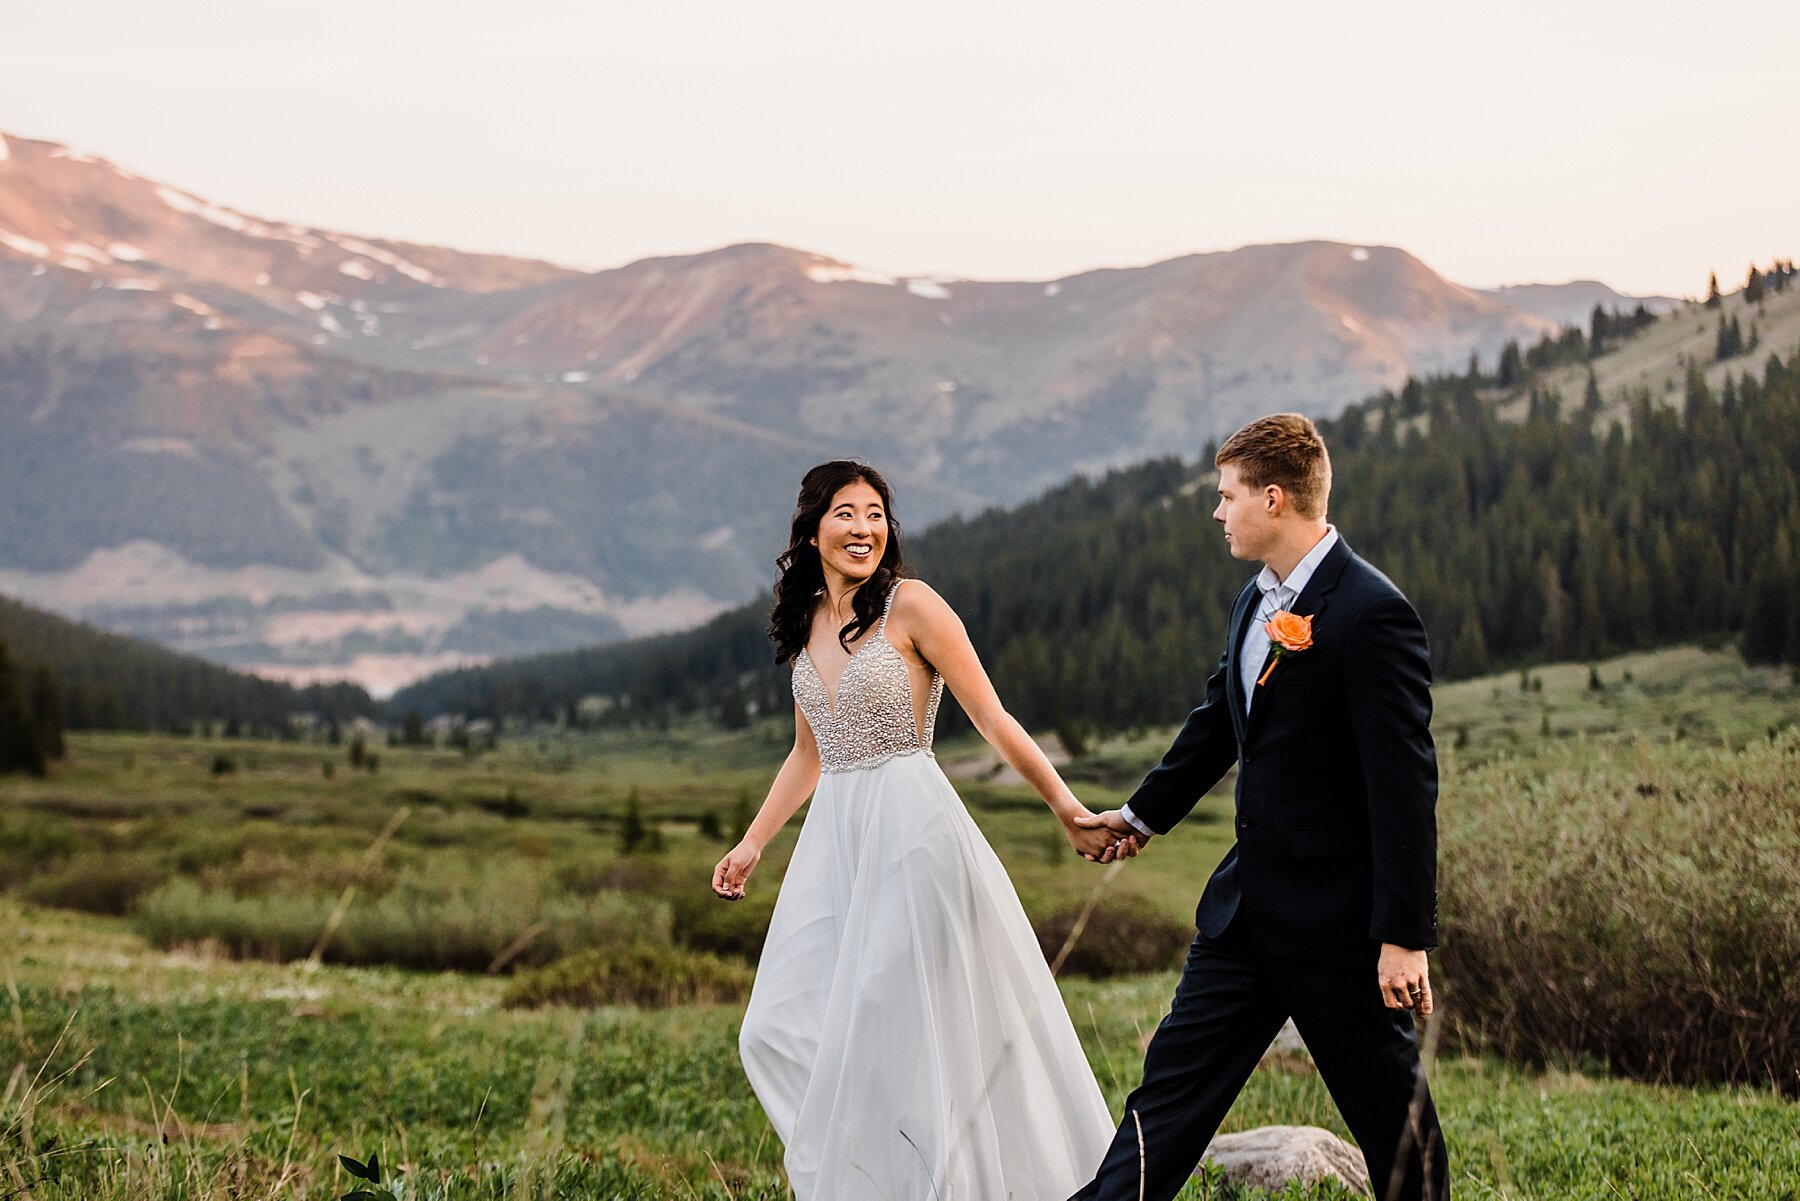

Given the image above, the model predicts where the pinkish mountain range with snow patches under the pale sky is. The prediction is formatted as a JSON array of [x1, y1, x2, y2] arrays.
[[0, 135, 1667, 691]]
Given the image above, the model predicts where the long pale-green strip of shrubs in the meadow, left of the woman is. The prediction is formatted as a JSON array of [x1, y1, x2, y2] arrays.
[[135, 870, 671, 971]]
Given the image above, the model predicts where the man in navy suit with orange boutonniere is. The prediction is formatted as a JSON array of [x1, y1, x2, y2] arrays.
[[1075, 414, 1449, 1201]]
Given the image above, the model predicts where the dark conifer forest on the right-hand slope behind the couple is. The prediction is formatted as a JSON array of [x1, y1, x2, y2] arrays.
[[396, 288, 1800, 736]]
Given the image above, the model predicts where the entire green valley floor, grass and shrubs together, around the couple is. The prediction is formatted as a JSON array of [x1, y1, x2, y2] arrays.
[[0, 648, 1800, 1201]]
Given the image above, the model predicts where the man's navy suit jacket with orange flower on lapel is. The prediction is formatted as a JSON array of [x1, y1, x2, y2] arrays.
[[1130, 537, 1438, 963]]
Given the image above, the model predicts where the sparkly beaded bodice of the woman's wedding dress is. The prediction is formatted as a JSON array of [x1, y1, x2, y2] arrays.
[[794, 580, 943, 772]]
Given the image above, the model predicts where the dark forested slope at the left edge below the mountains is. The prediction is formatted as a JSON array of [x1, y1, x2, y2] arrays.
[[0, 596, 378, 733]]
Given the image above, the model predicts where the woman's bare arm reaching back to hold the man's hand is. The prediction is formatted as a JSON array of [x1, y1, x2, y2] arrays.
[[889, 580, 1114, 859]]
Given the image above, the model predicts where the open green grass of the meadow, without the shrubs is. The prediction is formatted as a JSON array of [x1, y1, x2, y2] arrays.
[[0, 648, 1800, 1201]]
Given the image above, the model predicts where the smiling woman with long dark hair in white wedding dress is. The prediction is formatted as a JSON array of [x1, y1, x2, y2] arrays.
[[713, 461, 1118, 1201]]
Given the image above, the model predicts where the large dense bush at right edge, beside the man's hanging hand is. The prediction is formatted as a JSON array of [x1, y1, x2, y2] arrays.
[[1436, 731, 1800, 1093]]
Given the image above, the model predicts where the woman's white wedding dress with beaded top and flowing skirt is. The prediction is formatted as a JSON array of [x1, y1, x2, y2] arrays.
[[738, 583, 1112, 1201]]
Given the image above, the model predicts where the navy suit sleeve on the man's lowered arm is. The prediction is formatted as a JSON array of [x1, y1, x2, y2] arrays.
[[1345, 594, 1438, 951]]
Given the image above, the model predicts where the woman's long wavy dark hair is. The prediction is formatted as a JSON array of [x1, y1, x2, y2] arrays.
[[769, 459, 905, 663]]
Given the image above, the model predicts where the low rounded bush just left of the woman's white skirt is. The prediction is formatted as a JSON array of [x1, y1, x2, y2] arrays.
[[506, 944, 752, 1008]]
